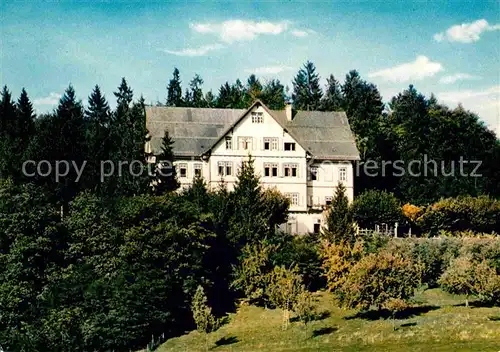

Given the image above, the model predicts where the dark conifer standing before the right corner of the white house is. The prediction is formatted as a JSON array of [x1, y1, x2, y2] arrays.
[[323, 182, 355, 244]]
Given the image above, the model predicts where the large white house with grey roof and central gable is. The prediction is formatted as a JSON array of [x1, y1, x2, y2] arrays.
[[146, 101, 359, 233]]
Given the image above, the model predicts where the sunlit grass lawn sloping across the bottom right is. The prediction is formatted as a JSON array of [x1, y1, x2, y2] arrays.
[[158, 289, 500, 352]]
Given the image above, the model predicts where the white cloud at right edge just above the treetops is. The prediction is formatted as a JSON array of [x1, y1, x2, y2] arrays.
[[436, 85, 500, 131]]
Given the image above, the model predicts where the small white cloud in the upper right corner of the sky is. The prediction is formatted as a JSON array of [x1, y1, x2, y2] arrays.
[[434, 18, 500, 43]]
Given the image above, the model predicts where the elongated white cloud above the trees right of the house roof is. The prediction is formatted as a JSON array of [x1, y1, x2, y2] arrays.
[[368, 56, 443, 82]]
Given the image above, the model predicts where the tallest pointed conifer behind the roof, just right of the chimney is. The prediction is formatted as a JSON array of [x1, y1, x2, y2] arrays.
[[292, 61, 323, 110]]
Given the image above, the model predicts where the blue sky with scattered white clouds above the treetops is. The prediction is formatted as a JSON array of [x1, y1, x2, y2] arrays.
[[0, 0, 500, 134]]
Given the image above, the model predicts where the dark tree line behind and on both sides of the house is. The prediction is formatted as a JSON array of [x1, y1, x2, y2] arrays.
[[0, 61, 500, 205]]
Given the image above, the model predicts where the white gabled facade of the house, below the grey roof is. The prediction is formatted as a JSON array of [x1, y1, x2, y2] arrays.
[[165, 105, 354, 233]]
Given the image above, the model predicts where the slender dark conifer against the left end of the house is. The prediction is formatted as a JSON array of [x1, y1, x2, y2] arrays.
[[155, 130, 179, 195]]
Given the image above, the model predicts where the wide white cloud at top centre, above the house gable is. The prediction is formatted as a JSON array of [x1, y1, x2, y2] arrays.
[[190, 20, 288, 43]]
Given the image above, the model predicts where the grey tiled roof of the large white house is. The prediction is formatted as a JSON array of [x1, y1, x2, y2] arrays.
[[146, 103, 359, 160]]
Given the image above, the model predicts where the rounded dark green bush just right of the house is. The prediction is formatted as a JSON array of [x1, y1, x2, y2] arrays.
[[351, 190, 402, 229]]
